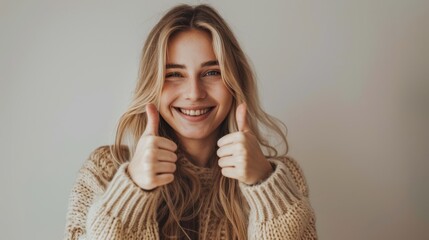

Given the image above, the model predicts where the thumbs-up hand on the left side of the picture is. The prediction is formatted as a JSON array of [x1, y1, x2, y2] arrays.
[[128, 103, 177, 191]]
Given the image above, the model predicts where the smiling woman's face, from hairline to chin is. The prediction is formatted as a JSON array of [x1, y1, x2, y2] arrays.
[[160, 30, 232, 143]]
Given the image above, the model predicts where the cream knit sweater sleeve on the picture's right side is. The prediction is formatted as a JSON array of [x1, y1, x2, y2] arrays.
[[240, 157, 317, 239]]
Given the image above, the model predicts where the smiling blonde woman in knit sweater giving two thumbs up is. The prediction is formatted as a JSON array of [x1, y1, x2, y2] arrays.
[[66, 5, 317, 239]]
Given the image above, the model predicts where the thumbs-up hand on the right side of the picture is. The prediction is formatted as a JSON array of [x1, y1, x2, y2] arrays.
[[217, 104, 273, 185]]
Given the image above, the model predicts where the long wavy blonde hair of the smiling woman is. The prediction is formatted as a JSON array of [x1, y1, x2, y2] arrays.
[[112, 5, 288, 239]]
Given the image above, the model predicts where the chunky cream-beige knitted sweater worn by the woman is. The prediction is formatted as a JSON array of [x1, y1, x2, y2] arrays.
[[64, 146, 317, 240]]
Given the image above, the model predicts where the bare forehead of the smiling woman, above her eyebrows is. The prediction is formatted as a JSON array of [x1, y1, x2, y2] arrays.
[[167, 29, 216, 64]]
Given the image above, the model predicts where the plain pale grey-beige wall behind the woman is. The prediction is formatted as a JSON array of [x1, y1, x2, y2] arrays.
[[0, 0, 429, 240]]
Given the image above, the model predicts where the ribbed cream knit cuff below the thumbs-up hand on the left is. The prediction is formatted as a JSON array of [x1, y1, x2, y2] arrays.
[[96, 162, 159, 229]]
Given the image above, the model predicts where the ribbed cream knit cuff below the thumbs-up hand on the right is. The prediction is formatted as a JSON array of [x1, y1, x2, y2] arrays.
[[239, 159, 302, 222]]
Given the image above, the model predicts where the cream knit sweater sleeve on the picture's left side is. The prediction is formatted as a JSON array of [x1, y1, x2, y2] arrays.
[[64, 147, 159, 240]]
